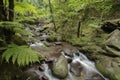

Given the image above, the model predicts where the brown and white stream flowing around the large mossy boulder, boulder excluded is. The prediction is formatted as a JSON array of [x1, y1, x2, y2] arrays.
[[21, 23, 109, 80]]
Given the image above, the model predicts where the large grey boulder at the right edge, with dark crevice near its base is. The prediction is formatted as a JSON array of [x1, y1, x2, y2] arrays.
[[105, 29, 120, 56]]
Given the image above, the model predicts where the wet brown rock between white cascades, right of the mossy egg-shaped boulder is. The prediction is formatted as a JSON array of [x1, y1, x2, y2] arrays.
[[70, 61, 82, 76]]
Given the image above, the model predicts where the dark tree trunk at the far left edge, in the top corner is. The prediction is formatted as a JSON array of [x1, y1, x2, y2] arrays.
[[0, 0, 7, 21]]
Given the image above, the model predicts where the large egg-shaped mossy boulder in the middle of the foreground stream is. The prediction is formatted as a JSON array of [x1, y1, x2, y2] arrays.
[[52, 55, 68, 79]]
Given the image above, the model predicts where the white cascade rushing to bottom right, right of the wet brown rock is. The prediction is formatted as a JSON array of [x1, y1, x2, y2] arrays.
[[73, 52, 108, 80]]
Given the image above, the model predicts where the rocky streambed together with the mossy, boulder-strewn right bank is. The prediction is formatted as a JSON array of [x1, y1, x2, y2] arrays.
[[17, 20, 120, 80]]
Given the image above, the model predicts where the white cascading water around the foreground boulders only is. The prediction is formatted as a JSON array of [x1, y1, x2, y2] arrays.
[[36, 52, 108, 80]]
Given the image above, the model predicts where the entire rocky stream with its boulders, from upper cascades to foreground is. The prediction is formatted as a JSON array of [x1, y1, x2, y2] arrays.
[[15, 20, 111, 80]]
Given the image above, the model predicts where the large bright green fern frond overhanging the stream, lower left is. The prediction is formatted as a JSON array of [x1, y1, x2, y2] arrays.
[[2, 44, 41, 66]]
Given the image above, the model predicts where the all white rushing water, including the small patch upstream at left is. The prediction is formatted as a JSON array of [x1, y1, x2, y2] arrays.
[[31, 43, 108, 80]]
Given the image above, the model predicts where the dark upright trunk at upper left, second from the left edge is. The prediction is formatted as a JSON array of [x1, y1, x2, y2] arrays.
[[9, 0, 14, 21]]
